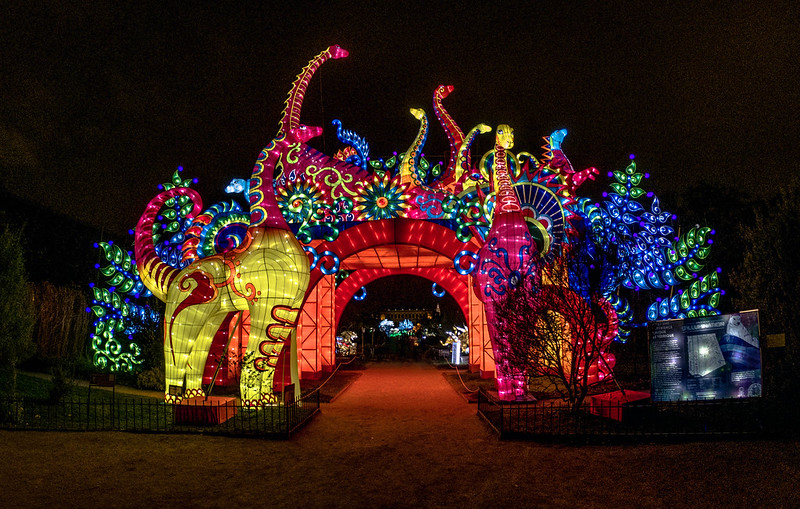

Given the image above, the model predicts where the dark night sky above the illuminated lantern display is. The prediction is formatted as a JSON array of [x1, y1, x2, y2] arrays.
[[0, 1, 800, 236]]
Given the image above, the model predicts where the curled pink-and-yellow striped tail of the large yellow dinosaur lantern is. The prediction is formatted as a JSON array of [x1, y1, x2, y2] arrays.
[[134, 187, 203, 301]]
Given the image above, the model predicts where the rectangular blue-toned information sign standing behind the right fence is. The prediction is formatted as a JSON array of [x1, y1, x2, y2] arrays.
[[648, 310, 761, 401]]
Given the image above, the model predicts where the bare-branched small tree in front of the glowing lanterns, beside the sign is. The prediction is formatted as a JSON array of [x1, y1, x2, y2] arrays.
[[496, 247, 618, 410]]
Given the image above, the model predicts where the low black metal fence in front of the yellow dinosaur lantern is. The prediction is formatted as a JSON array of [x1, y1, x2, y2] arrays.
[[0, 391, 320, 438]]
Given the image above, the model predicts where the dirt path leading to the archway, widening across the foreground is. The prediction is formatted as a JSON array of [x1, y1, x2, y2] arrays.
[[0, 364, 800, 508]]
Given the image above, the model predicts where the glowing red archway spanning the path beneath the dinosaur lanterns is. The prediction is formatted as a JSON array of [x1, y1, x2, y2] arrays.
[[296, 218, 494, 377]]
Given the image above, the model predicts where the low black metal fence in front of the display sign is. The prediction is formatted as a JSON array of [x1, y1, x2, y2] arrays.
[[478, 390, 777, 441]]
